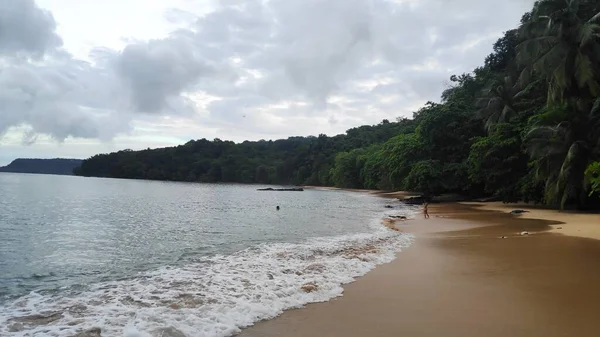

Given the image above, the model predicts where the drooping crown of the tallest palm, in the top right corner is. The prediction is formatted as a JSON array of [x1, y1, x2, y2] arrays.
[[517, 0, 600, 111]]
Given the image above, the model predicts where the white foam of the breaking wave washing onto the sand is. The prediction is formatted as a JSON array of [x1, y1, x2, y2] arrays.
[[0, 211, 412, 337]]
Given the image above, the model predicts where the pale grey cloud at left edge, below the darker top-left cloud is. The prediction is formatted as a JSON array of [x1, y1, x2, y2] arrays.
[[0, 58, 128, 143]]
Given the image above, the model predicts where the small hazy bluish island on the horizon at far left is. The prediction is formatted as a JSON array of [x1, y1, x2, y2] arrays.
[[0, 158, 83, 175]]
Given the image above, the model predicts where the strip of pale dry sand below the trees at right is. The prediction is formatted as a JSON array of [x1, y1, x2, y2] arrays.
[[464, 202, 600, 240]]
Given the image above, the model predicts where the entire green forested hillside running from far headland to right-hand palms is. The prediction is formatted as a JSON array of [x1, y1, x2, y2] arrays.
[[76, 0, 600, 208]]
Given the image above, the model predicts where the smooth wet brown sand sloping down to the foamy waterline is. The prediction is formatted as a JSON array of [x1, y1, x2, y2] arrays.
[[239, 205, 600, 337]]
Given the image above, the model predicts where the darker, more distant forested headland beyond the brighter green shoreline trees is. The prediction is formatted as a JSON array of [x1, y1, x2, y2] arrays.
[[76, 120, 414, 185]]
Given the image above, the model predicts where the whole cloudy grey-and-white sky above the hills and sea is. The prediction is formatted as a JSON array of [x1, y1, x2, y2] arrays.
[[0, 0, 534, 165]]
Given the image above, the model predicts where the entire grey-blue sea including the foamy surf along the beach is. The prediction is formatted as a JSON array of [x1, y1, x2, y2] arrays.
[[0, 173, 414, 337]]
